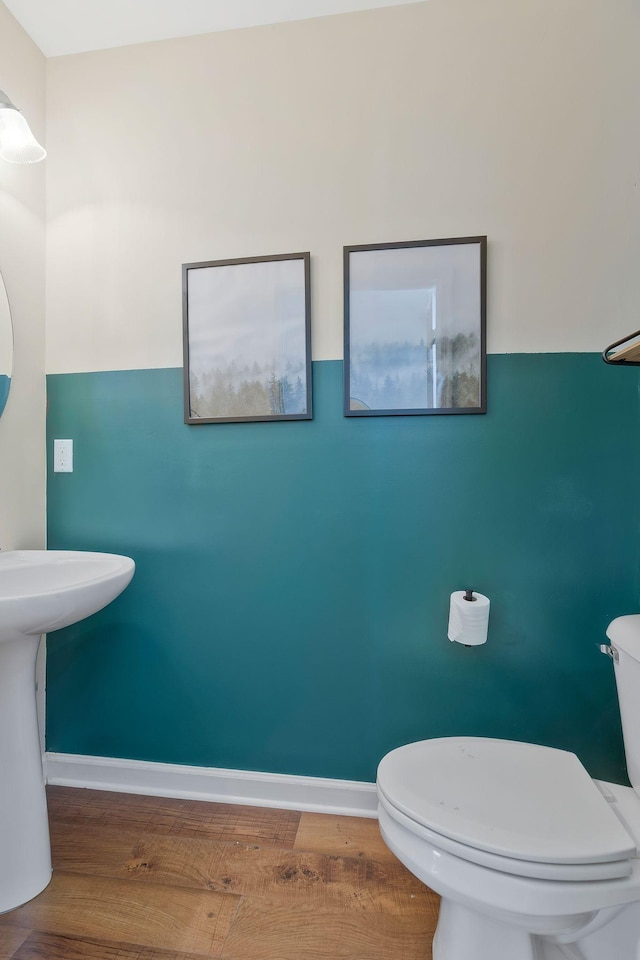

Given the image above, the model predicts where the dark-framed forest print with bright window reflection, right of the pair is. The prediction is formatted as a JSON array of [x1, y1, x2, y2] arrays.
[[344, 237, 486, 416]]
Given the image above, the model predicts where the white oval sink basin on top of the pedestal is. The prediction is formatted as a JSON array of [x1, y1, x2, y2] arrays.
[[0, 550, 135, 643]]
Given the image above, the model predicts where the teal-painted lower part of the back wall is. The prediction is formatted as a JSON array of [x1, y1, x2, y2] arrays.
[[47, 354, 640, 780]]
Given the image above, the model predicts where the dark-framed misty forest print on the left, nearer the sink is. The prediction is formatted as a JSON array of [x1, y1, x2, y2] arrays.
[[183, 253, 312, 423]]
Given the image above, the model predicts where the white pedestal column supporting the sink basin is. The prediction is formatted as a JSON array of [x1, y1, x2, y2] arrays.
[[0, 631, 51, 913]]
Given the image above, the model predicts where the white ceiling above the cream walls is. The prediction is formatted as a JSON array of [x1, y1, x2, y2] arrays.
[[4, 0, 417, 57]]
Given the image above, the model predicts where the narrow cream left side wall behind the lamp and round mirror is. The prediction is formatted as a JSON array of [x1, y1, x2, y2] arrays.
[[0, 2, 46, 550]]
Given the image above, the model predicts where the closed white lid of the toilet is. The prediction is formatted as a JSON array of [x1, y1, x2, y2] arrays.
[[377, 737, 636, 864]]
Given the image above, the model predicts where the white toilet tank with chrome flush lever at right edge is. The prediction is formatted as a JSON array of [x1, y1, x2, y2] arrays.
[[607, 614, 640, 794]]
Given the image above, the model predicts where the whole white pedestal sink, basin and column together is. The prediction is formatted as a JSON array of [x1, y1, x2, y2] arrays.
[[0, 550, 135, 913]]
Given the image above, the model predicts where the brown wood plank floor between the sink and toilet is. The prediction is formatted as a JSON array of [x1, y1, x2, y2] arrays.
[[0, 787, 438, 960]]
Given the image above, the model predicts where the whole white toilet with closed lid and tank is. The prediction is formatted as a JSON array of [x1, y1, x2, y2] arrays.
[[377, 615, 640, 960]]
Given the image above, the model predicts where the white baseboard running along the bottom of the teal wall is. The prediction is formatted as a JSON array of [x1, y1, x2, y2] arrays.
[[44, 753, 377, 818]]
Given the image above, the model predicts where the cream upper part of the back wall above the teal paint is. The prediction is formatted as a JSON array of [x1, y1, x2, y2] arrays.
[[47, 0, 640, 373]]
